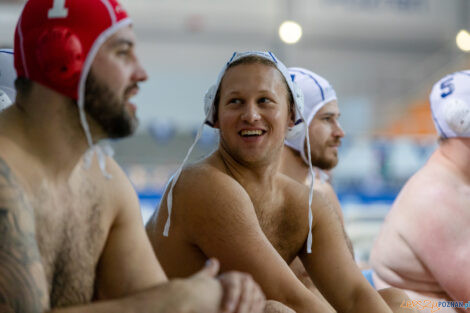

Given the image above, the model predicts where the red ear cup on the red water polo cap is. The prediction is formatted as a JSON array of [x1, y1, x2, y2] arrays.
[[36, 27, 84, 88]]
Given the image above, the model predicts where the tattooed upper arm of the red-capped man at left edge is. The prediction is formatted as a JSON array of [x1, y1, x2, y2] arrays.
[[0, 158, 49, 313]]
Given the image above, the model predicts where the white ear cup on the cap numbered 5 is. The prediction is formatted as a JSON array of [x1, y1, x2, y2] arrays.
[[443, 99, 470, 136]]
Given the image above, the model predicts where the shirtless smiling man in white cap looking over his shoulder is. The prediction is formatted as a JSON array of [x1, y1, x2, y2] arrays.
[[147, 52, 404, 313]]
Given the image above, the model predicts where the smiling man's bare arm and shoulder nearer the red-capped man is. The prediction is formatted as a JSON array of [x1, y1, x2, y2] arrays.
[[176, 173, 329, 312]]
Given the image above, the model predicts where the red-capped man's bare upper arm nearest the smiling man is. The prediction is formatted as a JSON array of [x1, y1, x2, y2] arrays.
[[96, 159, 167, 300]]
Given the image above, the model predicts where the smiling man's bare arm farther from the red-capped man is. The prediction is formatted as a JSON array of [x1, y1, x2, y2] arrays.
[[300, 189, 391, 312]]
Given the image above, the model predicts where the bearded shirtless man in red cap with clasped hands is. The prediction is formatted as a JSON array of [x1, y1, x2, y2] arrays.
[[0, 0, 263, 313]]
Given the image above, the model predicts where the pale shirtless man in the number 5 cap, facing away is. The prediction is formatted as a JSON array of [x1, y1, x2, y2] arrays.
[[371, 71, 470, 312]]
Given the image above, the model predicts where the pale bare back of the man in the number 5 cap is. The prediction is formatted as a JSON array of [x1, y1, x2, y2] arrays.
[[371, 147, 470, 301]]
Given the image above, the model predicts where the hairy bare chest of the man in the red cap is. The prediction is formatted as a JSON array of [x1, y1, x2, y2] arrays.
[[33, 184, 107, 307]]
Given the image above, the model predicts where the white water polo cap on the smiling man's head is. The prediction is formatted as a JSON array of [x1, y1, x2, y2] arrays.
[[204, 51, 304, 130]]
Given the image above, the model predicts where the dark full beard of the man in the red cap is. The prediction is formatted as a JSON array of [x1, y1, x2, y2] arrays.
[[85, 73, 138, 138]]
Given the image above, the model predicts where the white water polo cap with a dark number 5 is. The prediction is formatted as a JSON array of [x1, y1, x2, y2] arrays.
[[429, 70, 470, 138]]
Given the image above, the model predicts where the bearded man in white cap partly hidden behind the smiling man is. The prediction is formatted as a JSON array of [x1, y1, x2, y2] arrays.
[[280, 68, 348, 300]]
